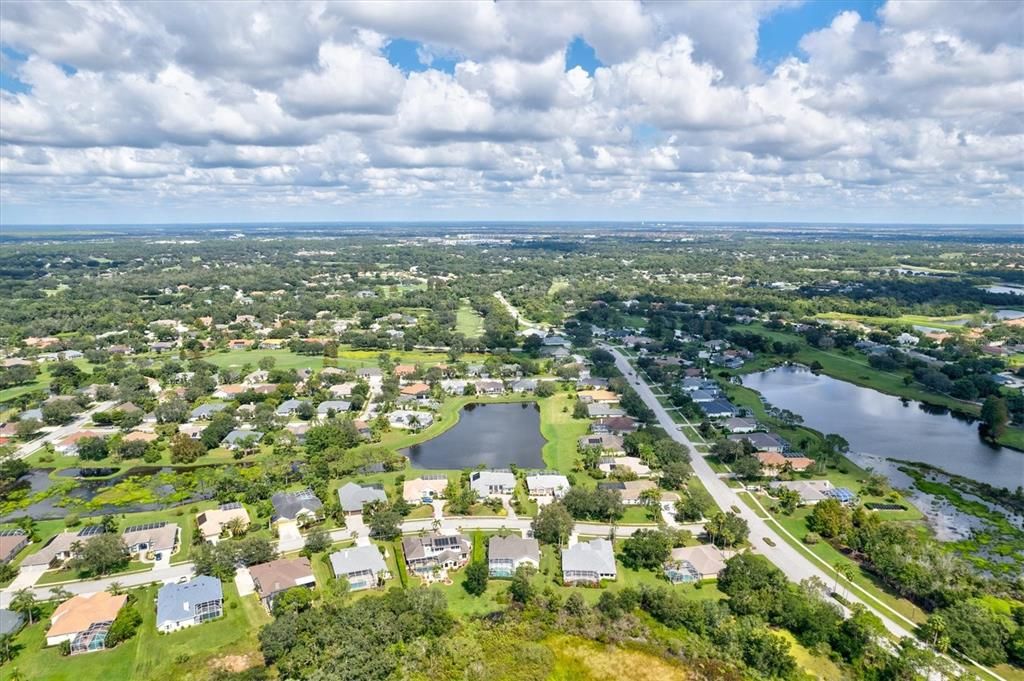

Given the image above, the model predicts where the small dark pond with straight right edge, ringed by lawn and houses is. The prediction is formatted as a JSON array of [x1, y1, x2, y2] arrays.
[[402, 402, 545, 469]]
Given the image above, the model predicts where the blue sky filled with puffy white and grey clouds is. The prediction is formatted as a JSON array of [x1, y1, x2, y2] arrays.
[[0, 0, 1024, 229]]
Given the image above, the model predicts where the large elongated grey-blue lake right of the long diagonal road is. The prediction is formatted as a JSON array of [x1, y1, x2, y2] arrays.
[[743, 367, 1024, 490]]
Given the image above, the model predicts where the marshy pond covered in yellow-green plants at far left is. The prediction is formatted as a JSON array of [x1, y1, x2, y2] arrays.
[[0, 466, 210, 521]]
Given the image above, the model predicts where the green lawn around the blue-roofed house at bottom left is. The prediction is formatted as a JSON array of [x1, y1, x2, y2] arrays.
[[4, 584, 269, 681]]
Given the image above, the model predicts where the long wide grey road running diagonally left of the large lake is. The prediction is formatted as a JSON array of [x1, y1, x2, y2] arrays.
[[604, 346, 913, 639]]
